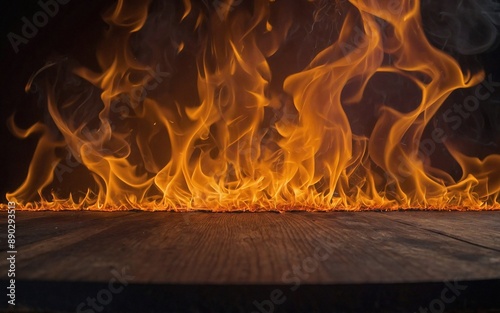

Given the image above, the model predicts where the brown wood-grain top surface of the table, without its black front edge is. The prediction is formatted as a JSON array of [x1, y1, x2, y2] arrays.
[[0, 211, 500, 312]]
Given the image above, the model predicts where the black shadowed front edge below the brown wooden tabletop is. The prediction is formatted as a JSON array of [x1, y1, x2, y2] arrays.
[[2, 280, 500, 313]]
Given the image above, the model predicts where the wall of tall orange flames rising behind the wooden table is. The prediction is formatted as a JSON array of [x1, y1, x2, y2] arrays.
[[7, 0, 500, 211]]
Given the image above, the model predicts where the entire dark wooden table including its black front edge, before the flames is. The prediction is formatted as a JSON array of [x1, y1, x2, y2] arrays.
[[0, 211, 500, 313]]
